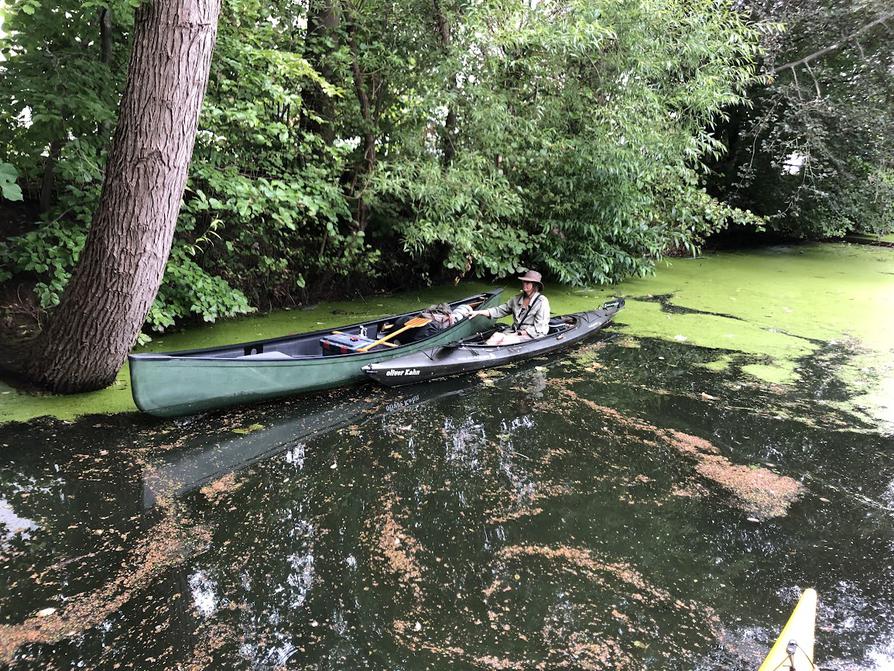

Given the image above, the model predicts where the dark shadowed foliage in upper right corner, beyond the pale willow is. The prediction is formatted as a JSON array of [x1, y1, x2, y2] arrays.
[[713, 0, 894, 238]]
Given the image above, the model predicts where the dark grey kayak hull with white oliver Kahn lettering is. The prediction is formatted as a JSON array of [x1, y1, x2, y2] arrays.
[[363, 302, 623, 387]]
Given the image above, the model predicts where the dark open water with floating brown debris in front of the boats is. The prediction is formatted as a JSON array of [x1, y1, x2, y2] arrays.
[[0, 336, 894, 670]]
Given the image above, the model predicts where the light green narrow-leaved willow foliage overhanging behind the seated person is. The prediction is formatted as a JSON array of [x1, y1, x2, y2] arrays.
[[363, 0, 759, 284]]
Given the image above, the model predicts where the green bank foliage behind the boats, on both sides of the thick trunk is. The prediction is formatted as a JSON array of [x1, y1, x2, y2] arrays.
[[0, 0, 772, 342]]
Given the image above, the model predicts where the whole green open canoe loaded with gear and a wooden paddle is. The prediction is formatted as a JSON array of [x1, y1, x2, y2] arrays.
[[129, 290, 501, 417]]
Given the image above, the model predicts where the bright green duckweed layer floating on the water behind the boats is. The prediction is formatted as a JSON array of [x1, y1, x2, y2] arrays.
[[0, 243, 894, 423]]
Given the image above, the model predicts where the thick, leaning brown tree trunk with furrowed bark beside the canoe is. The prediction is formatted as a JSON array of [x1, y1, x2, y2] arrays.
[[28, 0, 220, 393]]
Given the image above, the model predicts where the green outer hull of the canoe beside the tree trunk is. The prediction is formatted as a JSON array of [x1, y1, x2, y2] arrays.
[[130, 292, 499, 417]]
